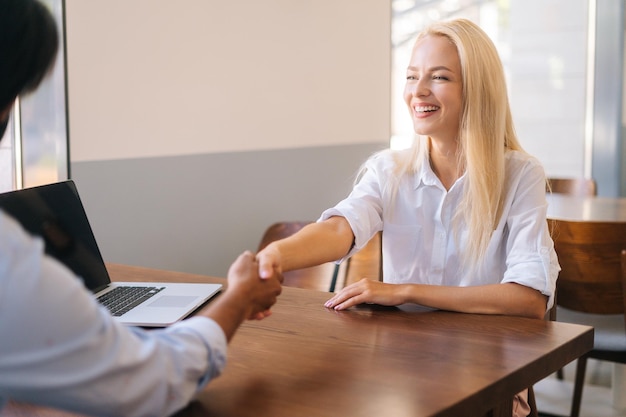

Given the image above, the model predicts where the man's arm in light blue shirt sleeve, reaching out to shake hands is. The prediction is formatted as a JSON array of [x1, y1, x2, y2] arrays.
[[0, 215, 280, 417]]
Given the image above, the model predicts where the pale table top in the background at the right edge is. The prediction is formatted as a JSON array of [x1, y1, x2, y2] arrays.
[[546, 194, 626, 222]]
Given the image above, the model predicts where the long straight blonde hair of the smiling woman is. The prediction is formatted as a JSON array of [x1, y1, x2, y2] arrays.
[[391, 19, 523, 264]]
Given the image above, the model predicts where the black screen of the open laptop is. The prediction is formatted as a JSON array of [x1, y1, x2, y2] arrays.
[[0, 180, 111, 292]]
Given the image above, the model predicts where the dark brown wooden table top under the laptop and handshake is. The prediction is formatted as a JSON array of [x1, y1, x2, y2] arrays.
[[2, 265, 593, 417]]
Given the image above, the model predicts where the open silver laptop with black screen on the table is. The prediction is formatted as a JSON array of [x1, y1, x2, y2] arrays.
[[0, 180, 222, 327]]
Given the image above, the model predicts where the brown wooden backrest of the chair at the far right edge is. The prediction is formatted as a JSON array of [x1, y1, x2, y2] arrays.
[[548, 219, 626, 314]]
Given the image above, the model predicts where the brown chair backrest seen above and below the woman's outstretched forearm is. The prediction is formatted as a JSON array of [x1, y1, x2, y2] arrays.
[[258, 221, 335, 291]]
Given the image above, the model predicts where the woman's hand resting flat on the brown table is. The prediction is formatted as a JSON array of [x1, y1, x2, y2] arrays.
[[324, 278, 406, 310]]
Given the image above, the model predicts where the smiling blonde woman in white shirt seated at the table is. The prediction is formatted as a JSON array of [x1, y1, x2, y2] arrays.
[[257, 19, 560, 415]]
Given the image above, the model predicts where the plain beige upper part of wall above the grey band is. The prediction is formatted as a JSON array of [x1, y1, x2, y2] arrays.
[[66, 0, 391, 162]]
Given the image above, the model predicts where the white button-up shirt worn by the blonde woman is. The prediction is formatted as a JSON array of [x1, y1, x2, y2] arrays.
[[320, 151, 560, 308]]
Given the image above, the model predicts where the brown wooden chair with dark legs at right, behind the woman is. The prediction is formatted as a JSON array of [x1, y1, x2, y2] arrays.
[[549, 220, 626, 417]]
